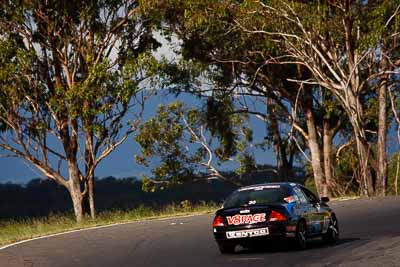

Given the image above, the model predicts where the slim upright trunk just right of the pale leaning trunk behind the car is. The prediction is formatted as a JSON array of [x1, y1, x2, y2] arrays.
[[323, 120, 334, 196]]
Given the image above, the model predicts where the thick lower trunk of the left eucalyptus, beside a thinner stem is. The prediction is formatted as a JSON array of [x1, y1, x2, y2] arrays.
[[68, 162, 83, 223]]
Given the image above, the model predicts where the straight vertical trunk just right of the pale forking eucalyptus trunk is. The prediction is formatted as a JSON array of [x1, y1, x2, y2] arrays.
[[376, 57, 389, 196]]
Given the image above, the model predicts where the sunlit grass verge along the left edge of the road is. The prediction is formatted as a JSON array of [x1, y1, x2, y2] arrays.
[[0, 201, 219, 247]]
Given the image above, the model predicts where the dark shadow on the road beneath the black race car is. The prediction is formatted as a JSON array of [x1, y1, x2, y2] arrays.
[[236, 238, 361, 254]]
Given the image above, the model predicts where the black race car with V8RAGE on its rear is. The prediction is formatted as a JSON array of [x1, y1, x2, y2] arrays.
[[213, 183, 339, 253]]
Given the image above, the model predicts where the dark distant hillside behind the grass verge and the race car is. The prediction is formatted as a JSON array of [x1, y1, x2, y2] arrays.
[[0, 166, 304, 219]]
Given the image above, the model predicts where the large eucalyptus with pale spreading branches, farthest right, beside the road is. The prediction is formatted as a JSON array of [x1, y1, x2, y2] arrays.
[[228, 0, 400, 195]]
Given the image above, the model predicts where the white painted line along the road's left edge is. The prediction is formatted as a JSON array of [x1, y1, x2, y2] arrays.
[[0, 213, 207, 251]]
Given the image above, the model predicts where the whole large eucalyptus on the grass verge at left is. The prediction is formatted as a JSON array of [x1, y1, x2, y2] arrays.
[[0, 0, 159, 222]]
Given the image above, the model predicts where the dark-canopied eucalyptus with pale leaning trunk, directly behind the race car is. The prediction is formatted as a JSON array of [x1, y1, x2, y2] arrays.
[[143, 0, 350, 195]]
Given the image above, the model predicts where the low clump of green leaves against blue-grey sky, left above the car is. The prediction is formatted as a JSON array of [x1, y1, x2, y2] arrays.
[[135, 102, 204, 188]]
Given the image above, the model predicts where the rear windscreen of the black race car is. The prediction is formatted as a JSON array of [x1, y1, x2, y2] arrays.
[[224, 185, 290, 208]]
